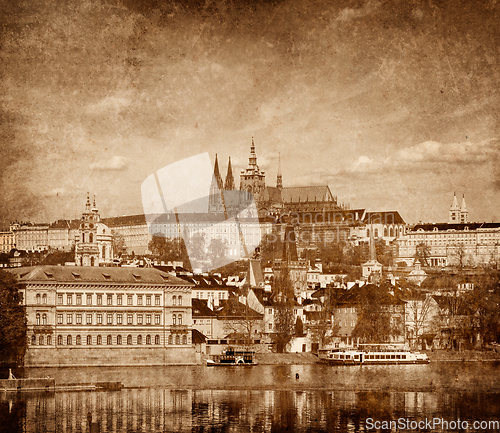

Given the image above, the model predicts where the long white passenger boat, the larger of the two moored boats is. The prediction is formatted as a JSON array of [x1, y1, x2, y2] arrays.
[[318, 344, 429, 365]]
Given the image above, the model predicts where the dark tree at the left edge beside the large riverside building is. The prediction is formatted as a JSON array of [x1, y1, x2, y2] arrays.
[[0, 269, 27, 368]]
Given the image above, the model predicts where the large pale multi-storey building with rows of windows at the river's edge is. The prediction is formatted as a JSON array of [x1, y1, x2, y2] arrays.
[[10, 266, 195, 367]]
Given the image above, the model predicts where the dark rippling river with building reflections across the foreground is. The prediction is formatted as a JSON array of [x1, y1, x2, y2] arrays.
[[0, 362, 500, 433]]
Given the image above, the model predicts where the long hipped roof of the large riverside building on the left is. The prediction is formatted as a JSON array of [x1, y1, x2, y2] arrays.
[[9, 266, 191, 286]]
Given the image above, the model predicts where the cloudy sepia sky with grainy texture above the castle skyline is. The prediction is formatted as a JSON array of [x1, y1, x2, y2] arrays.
[[0, 0, 500, 226]]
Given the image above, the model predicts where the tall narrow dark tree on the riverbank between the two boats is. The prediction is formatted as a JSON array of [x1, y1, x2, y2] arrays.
[[273, 263, 295, 353]]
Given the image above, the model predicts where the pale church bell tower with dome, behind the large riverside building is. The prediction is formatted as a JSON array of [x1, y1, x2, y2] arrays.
[[75, 193, 113, 266]]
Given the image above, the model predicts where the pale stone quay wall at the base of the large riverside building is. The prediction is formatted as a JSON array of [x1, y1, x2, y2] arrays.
[[25, 346, 201, 367]]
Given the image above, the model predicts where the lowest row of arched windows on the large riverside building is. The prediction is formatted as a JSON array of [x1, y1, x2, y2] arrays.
[[31, 334, 187, 346]]
